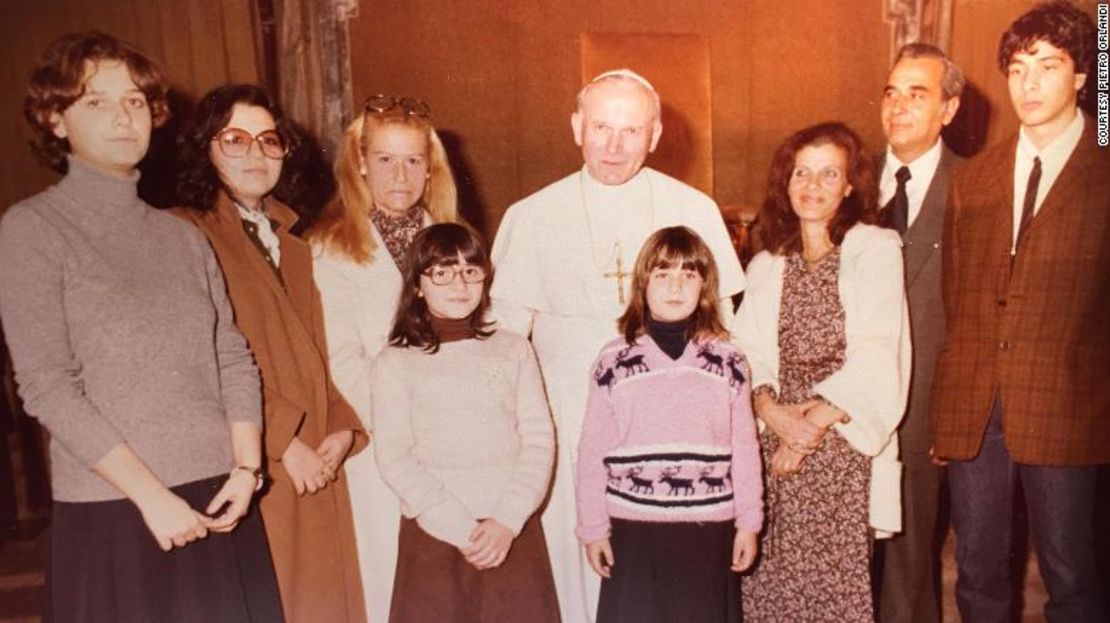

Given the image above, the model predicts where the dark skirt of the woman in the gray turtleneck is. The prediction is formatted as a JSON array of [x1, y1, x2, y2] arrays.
[[44, 475, 283, 622]]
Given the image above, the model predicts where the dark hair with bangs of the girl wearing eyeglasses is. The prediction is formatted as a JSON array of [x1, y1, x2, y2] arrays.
[[390, 223, 494, 353]]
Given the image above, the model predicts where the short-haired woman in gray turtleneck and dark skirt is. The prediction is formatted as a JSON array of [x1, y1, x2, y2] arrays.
[[0, 32, 282, 621]]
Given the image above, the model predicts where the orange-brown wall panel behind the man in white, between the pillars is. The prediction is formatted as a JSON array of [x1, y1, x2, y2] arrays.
[[350, 0, 890, 240]]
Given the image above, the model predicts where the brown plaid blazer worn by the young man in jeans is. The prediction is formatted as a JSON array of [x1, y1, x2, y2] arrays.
[[931, 117, 1110, 465]]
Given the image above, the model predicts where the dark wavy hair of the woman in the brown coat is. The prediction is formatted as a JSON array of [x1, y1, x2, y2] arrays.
[[175, 84, 304, 211]]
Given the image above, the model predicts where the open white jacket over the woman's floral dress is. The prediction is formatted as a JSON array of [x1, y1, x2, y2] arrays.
[[731, 224, 912, 537]]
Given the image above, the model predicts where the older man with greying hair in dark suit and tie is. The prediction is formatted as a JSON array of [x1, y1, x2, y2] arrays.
[[879, 43, 963, 623]]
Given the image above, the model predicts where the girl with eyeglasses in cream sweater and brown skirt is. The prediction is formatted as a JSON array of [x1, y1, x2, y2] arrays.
[[371, 223, 558, 623]]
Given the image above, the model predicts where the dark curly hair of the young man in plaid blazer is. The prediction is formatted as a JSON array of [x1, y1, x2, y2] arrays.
[[998, 0, 1097, 84]]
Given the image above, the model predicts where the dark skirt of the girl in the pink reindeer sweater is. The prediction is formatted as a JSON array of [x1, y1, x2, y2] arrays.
[[597, 519, 740, 623]]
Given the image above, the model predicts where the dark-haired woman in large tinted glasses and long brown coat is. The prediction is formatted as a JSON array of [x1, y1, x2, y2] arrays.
[[170, 84, 366, 621]]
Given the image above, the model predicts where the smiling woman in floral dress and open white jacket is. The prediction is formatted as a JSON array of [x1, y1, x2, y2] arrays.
[[731, 122, 910, 622]]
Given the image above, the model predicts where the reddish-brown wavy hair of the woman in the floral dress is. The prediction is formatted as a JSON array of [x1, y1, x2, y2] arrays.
[[759, 121, 878, 254]]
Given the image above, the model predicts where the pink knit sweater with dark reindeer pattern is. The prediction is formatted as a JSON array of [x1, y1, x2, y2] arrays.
[[576, 335, 763, 544]]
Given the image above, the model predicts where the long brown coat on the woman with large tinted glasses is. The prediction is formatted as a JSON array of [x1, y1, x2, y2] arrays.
[[178, 193, 366, 622]]
